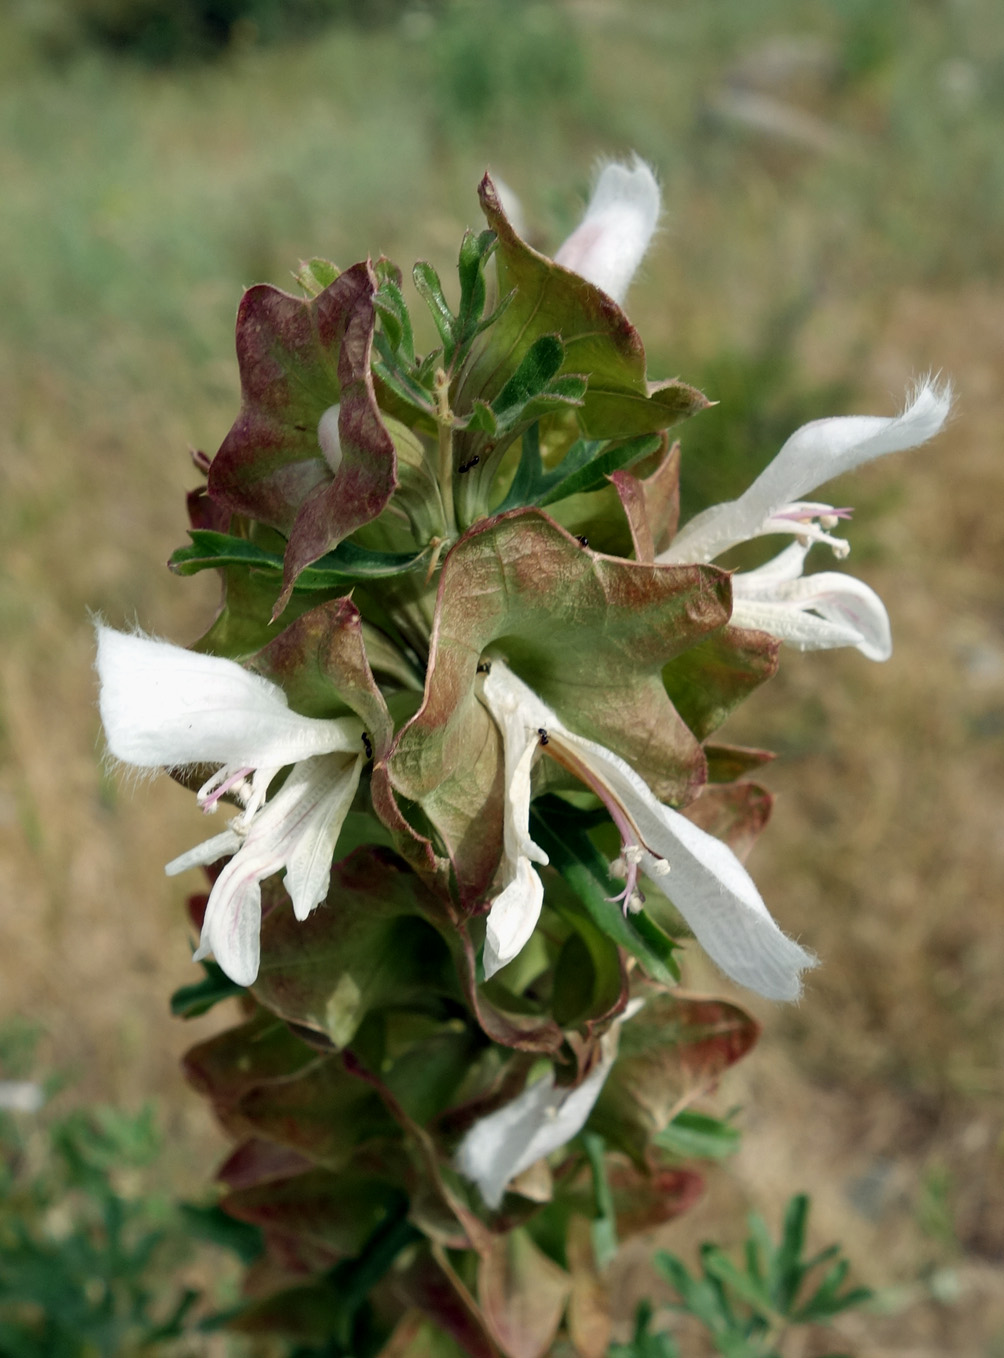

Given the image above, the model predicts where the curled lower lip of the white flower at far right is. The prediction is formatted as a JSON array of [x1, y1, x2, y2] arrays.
[[732, 542, 893, 660]]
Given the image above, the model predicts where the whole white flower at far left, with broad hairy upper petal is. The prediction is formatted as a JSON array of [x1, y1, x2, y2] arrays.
[[98, 627, 363, 986]]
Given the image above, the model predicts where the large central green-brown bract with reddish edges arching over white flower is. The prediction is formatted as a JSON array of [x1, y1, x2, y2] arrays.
[[389, 509, 730, 904]]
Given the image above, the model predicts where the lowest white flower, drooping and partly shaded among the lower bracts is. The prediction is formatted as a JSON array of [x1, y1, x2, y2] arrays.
[[454, 999, 643, 1207]]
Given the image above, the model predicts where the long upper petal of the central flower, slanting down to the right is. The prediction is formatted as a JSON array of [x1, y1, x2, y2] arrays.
[[564, 735, 815, 999]]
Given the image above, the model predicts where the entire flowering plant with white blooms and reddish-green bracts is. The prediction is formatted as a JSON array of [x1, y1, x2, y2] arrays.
[[98, 160, 948, 1358]]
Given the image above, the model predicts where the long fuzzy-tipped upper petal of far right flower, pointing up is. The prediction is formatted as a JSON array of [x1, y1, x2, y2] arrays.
[[659, 382, 951, 564]]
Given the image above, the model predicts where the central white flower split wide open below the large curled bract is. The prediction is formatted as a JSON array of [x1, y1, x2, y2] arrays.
[[482, 660, 815, 999]]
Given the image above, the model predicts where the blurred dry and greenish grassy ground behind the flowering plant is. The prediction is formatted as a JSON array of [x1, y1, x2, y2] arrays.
[[0, 0, 1004, 1358]]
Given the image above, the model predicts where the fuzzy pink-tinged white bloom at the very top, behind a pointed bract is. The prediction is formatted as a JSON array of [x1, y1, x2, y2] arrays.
[[554, 156, 662, 303]]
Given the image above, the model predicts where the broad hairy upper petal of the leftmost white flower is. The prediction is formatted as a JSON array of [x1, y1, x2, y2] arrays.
[[98, 627, 363, 769]]
